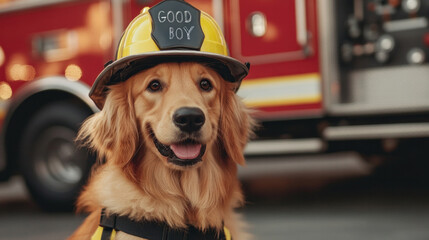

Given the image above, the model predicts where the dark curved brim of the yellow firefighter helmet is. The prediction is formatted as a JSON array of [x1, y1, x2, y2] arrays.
[[89, 50, 249, 109]]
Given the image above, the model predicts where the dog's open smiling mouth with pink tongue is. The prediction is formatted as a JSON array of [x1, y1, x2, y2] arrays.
[[149, 129, 206, 167]]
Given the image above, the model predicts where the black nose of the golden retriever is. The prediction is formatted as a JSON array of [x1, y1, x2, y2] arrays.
[[173, 107, 206, 132]]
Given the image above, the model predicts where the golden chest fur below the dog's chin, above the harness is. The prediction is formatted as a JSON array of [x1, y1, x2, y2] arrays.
[[89, 156, 241, 231]]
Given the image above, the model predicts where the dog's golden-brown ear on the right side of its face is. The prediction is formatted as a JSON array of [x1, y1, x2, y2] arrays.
[[218, 87, 254, 166]]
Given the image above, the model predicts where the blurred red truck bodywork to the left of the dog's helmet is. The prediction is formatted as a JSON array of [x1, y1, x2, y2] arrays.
[[0, 0, 111, 92]]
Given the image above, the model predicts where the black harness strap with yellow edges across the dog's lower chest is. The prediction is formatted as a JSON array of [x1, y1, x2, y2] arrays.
[[91, 209, 231, 240]]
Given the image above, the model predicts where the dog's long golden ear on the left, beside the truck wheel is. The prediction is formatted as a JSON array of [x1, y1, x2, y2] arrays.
[[77, 83, 139, 167]]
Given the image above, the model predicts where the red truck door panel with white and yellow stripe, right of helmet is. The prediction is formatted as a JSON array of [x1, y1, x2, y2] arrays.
[[224, 0, 322, 119]]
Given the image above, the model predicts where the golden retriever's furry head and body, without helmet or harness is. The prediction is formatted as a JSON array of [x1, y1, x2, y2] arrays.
[[70, 62, 253, 240]]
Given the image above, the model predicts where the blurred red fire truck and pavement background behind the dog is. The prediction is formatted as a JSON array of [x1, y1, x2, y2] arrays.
[[0, 0, 429, 240]]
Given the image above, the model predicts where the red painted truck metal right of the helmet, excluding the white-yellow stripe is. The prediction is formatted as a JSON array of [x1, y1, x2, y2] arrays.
[[224, 0, 322, 118]]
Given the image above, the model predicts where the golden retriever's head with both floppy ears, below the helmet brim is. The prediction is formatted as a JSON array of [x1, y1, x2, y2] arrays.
[[78, 62, 252, 175]]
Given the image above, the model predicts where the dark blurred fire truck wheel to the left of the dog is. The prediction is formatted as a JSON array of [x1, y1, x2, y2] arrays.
[[19, 102, 95, 211]]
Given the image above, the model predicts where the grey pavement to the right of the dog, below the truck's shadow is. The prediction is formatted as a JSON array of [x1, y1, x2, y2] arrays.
[[246, 191, 429, 240]]
